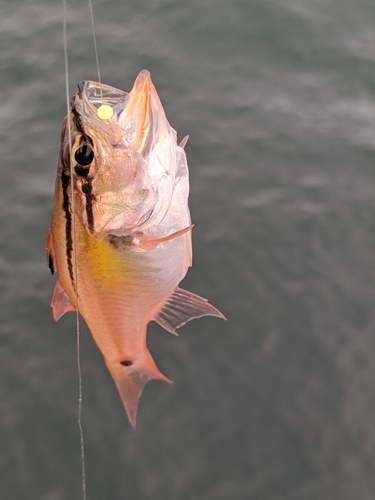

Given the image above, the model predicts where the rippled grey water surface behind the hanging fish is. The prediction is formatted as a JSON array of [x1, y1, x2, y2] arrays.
[[0, 0, 375, 500]]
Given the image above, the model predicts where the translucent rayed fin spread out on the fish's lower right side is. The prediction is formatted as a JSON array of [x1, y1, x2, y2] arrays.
[[154, 287, 226, 335]]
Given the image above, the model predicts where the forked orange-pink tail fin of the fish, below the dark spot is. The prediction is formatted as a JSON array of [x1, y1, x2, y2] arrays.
[[106, 350, 172, 428]]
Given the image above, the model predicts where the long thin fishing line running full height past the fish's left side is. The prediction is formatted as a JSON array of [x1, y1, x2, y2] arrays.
[[62, 0, 87, 500]]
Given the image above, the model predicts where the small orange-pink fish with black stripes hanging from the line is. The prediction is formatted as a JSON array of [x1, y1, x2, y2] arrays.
[[46, 70, 225, 427]]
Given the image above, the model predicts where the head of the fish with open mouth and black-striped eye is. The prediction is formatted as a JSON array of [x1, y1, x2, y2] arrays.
[[63, 70, 177, 240]]
